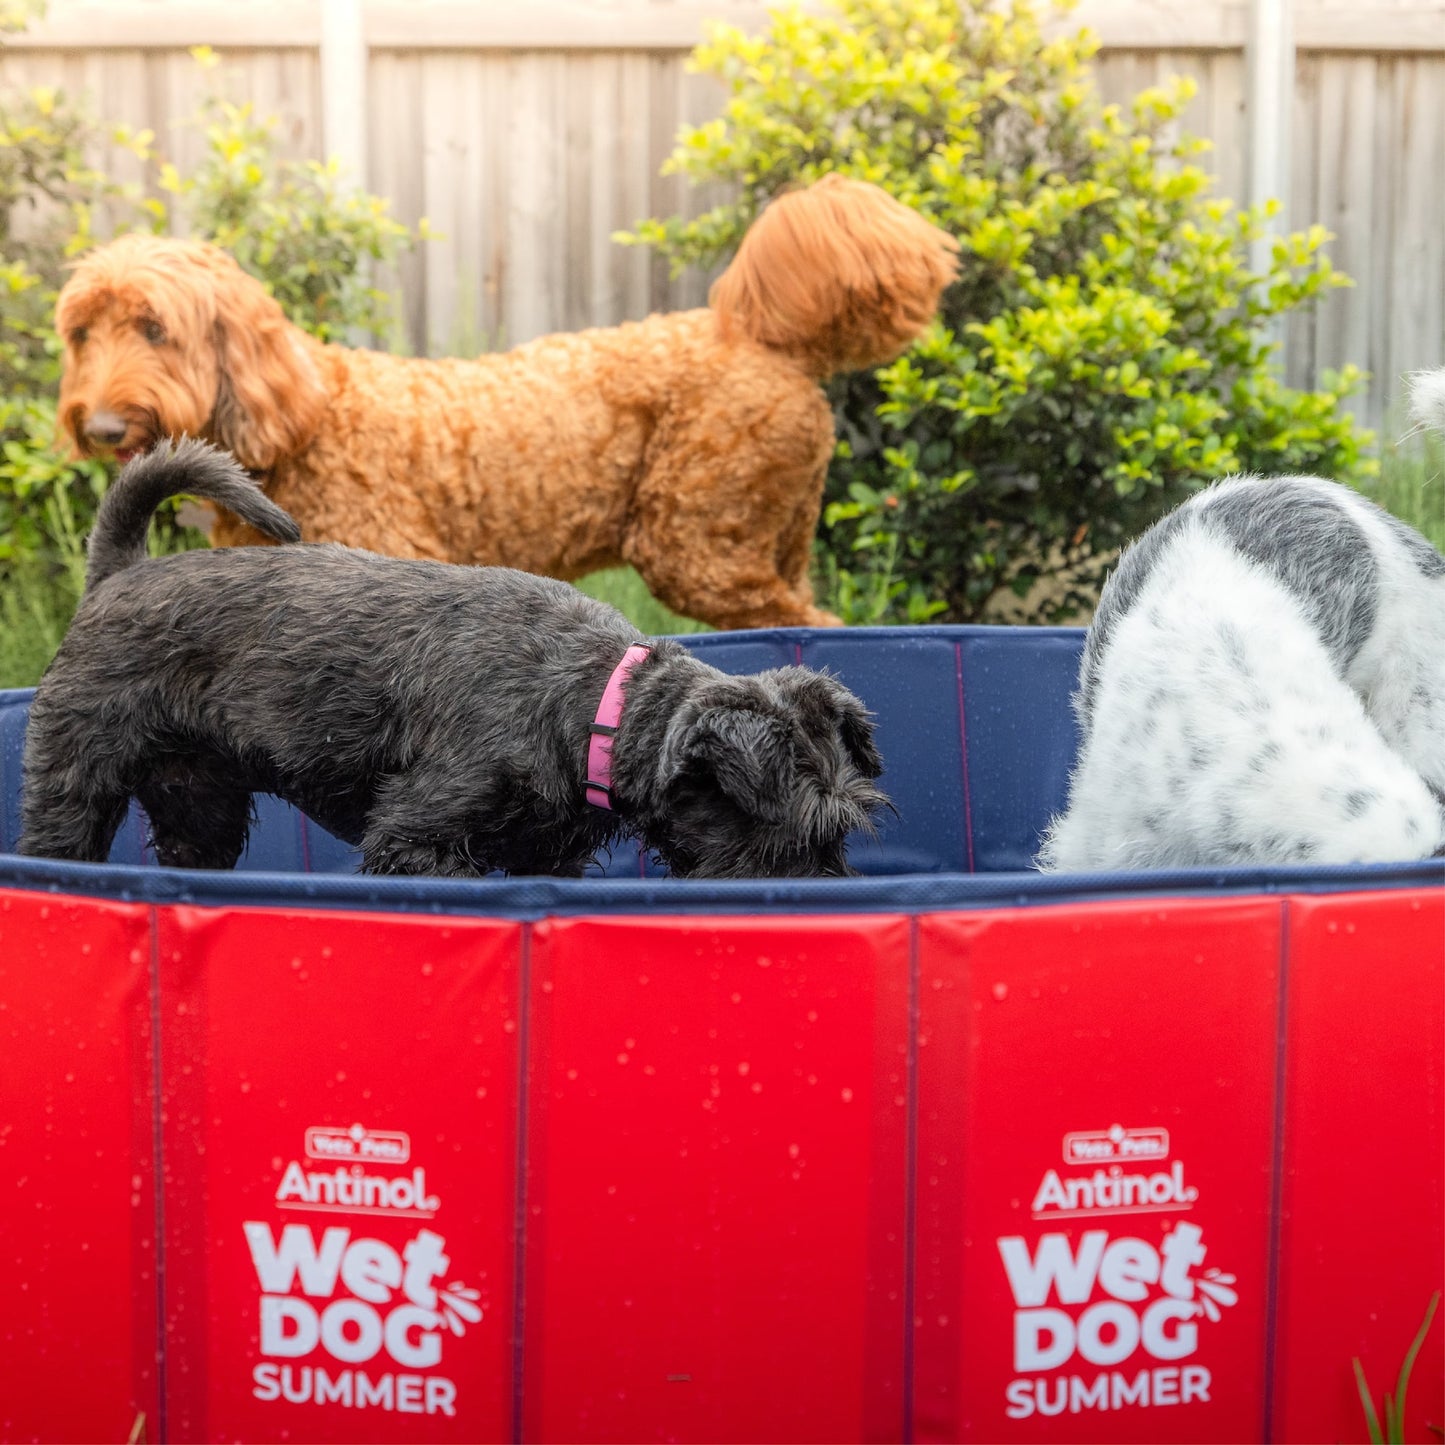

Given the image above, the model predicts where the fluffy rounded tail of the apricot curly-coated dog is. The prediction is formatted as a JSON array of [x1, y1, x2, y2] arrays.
[[708, 175, 958, 379]]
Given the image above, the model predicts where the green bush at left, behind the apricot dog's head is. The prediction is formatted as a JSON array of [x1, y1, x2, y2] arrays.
[[0, 14, 412, 686]]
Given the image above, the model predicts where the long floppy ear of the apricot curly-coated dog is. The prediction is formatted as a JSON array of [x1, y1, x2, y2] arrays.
[[210, 262, 327, 471]]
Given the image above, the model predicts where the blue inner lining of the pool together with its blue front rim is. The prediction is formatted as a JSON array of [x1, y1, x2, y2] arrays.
[[0, 627, 1445, 916]]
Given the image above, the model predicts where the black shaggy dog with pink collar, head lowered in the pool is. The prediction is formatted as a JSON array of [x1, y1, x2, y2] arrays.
[[20, 441, 887, 877]]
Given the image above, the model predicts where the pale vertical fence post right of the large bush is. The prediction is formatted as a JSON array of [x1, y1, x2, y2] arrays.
[[1246, 0, 1295, 366]]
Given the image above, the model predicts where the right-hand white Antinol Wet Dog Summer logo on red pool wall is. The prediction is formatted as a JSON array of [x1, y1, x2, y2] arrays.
[[997, 1124, 1240, 1420]]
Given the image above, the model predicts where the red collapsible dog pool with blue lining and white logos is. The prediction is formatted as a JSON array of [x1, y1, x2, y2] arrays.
[[0, 627, 1445, 1441]]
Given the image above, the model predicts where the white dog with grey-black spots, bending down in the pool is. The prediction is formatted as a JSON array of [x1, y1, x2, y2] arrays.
[[1038, 368, 1445, 870]]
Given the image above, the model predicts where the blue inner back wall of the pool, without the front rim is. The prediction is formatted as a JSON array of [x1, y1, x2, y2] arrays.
[[0, 627, 1084, 879]]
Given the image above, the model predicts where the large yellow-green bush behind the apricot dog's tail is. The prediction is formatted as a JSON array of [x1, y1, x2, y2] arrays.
[[627, 0, 1373, 621]]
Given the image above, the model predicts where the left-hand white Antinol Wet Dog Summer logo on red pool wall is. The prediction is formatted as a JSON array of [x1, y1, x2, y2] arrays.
[[241, 1124, 483, 1416]]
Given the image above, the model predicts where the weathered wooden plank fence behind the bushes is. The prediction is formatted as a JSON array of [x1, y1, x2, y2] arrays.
[[0, 0, 1445, 431]]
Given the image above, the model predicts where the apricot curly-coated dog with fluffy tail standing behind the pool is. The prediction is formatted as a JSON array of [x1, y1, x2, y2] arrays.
[[56, 176, 957, 627]]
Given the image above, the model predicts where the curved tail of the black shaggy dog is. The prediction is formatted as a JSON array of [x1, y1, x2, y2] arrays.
[[85, 436, 301, 592]]
